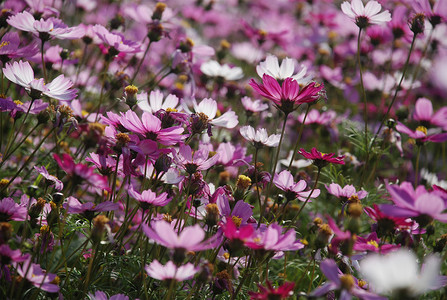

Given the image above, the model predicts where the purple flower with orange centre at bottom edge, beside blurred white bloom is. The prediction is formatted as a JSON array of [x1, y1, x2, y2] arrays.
[[310, 259, 386, 300]]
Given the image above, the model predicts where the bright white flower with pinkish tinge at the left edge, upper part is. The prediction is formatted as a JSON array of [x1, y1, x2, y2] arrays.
[[3, 61, 77, 100]]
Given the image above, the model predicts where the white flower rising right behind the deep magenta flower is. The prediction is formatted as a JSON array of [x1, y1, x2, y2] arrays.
[[256, 55, 310, 83]]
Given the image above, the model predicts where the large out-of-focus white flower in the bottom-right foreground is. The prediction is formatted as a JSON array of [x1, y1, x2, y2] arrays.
[[360, 249, 445, 297]]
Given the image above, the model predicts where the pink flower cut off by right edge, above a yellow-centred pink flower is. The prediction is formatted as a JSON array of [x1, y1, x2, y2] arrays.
[[413, 98, 447, 130]]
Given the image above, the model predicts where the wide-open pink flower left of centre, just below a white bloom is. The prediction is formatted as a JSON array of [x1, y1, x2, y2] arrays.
[[120, 110, 186, 146]]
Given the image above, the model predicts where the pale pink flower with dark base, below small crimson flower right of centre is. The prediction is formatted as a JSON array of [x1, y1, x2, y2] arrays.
[[273, 170, 320, 202]]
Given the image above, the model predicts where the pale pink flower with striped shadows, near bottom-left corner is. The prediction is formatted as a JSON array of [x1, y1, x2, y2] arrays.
[[14, 260, 59, 293]]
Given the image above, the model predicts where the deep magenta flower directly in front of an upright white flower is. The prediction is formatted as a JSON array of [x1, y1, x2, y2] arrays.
[[249, 74, 324, 115]]
